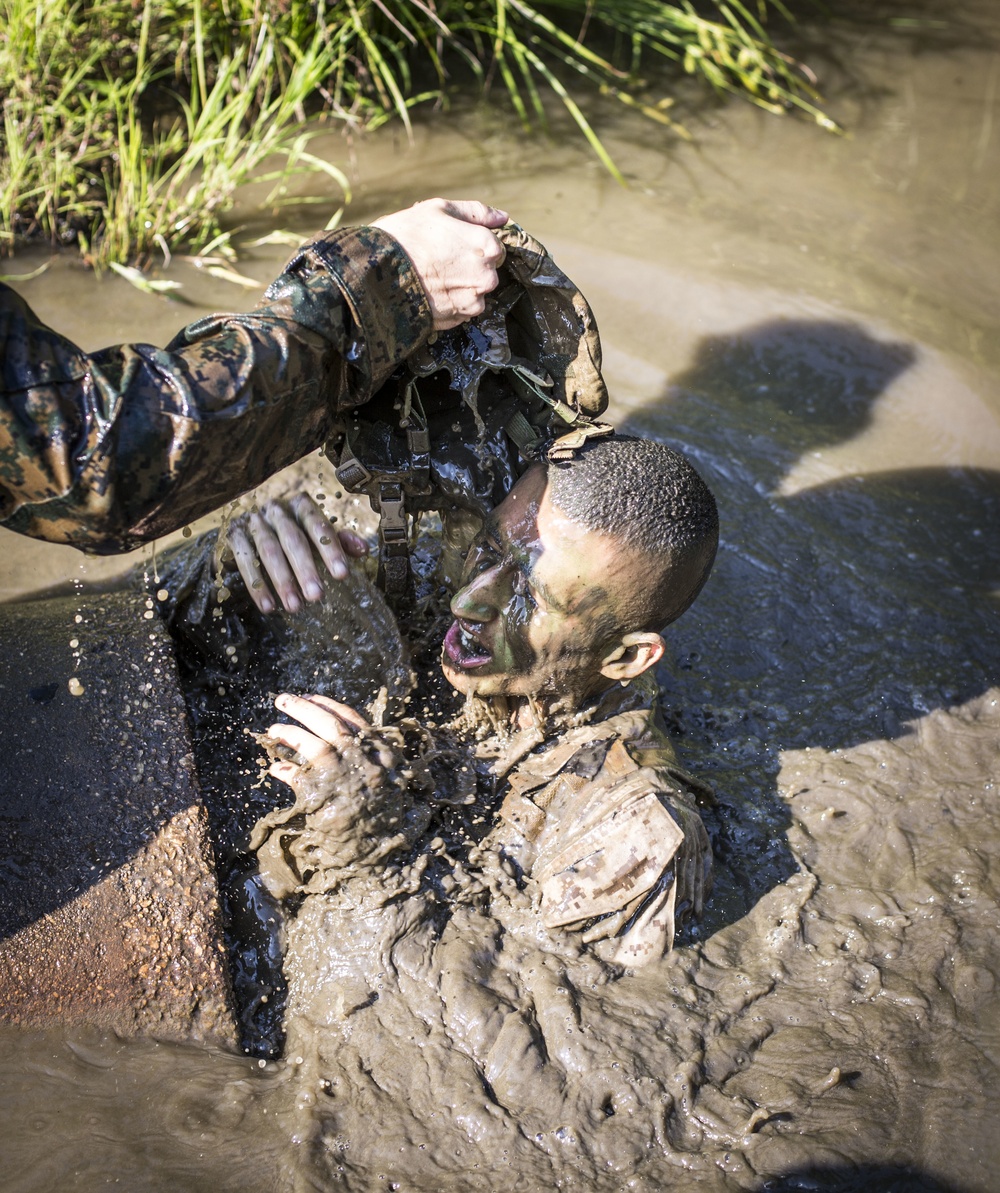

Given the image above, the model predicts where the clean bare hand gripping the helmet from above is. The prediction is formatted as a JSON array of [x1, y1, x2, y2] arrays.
[[374, 199, 507, 332]]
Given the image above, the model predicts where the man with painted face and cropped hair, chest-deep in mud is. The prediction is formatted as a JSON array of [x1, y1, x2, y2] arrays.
[[255, 437, 718, 968]]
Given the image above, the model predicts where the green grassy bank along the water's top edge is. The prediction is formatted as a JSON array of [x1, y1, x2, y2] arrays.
[[0, 0, 828, 267]]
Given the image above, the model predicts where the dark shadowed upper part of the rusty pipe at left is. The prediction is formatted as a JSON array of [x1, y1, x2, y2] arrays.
[[0, 594, 197, 937]]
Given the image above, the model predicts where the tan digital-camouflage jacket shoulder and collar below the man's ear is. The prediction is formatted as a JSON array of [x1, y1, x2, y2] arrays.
[[489, 676, 714, 968]]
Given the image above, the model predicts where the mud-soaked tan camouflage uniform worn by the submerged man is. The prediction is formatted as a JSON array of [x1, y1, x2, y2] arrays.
[[251, 675, 715, 969]]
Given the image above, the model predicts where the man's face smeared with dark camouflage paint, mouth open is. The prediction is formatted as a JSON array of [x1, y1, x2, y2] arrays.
[[442, 466, 641, 699]]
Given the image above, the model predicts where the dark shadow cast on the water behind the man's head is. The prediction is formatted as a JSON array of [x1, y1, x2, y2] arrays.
[[625, 321, 1000, 931]]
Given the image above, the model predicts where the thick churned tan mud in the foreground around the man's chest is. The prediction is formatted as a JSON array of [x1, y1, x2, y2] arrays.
[[244, 560, 1000, 1191]]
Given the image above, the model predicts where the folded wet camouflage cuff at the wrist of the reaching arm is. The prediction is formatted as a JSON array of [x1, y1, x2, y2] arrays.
[[293, 227, 433, 384]]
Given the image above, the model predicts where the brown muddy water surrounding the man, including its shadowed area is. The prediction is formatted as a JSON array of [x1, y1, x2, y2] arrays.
[[0, 4, 1000, 1193]]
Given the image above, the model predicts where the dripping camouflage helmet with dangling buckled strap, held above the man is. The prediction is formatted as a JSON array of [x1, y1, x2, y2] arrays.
[[327, 223, 612, 594]]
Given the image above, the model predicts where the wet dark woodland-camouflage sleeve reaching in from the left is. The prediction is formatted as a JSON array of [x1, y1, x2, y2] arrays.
[[0, 228, 431, 554]]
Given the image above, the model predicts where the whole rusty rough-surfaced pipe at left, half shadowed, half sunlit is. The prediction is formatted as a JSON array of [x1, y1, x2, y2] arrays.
[[0, 593, 236, 1046]]
